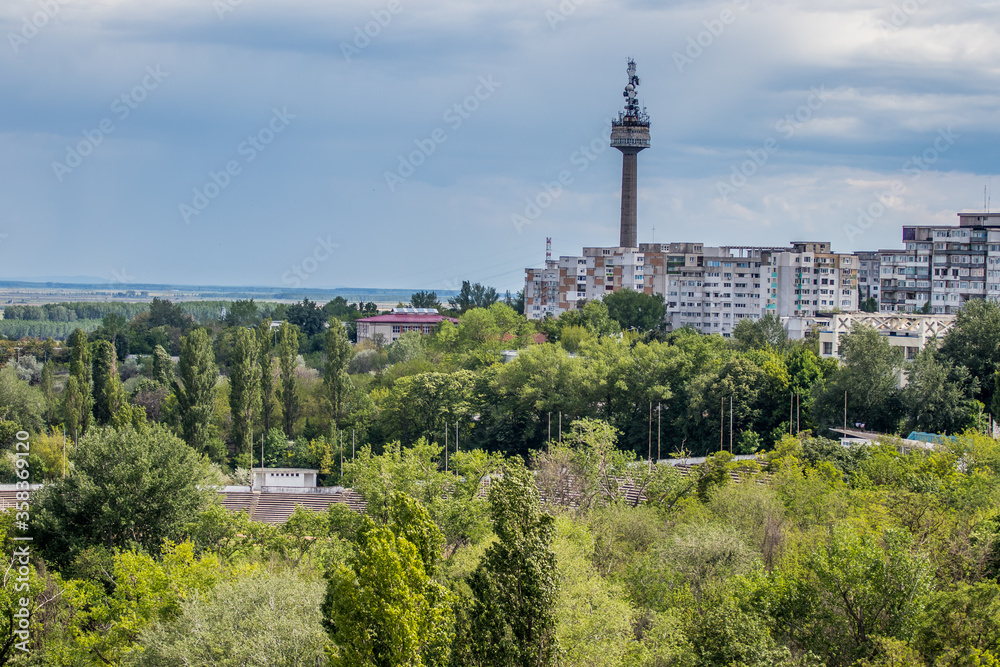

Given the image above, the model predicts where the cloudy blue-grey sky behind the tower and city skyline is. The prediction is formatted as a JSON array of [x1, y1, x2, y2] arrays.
[[0, 0, 1000, 291]]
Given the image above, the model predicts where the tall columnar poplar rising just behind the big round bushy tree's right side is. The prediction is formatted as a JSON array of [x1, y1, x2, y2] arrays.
[[174, 329, 219, 452]]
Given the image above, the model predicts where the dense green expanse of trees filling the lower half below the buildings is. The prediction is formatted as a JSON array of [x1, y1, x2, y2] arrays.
[[0, 296, 1000, 667]]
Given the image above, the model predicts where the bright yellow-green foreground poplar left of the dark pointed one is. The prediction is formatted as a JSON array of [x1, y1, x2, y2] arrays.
[[323, 493, 455, 667]]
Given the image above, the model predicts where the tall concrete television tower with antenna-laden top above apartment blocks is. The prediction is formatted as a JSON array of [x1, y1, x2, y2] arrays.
[[611, 58, 649, 248]]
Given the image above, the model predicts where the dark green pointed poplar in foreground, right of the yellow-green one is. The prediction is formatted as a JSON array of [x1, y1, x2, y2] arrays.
[[461, 464, 558, 667]]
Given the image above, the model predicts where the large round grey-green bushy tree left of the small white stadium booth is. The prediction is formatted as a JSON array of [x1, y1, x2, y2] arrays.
[[32, 425, 218, 565]]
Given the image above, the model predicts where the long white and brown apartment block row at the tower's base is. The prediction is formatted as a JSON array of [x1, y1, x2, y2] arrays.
[[525, 242, 858, 338]]
